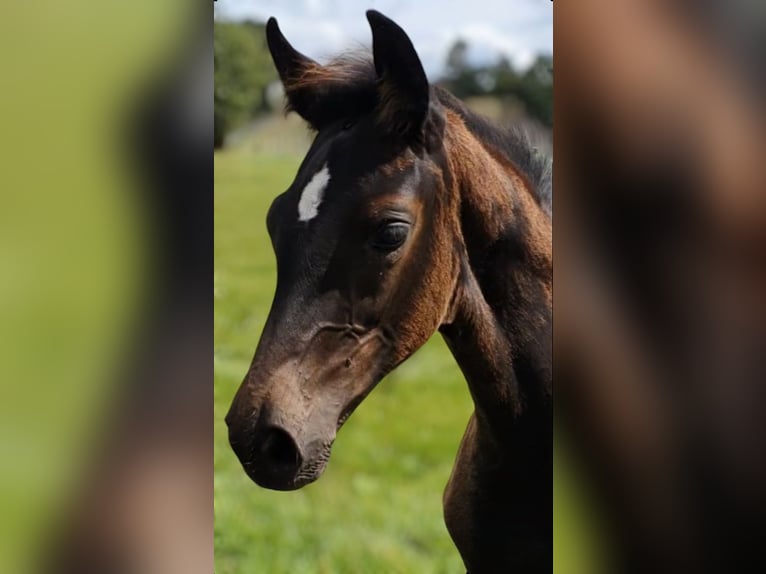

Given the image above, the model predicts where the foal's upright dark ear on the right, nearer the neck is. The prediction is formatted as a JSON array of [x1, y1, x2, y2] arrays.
[[367, 10, 429, 137]]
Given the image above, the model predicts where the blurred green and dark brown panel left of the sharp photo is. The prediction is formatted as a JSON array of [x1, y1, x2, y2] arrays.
[[0, 0, 213, 573]]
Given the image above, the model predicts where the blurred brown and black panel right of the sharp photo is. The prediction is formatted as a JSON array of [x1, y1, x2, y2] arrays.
[[554, 0, 766, 573]]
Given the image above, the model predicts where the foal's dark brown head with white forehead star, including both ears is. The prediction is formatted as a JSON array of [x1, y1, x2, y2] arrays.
[[226, 11, 460, 490]]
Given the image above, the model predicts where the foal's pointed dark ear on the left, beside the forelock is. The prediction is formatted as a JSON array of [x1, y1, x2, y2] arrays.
[[266, 17, 322, 127]]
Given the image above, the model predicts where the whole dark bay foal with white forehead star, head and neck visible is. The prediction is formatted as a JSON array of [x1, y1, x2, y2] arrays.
[[226, 11, 553, 573]]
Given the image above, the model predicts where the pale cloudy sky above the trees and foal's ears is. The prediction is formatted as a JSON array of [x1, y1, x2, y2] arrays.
[[216, 0, 553, 80]]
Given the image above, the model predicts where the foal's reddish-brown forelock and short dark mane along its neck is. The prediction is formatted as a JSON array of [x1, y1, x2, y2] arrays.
[[284, 52, 553, 216]]
